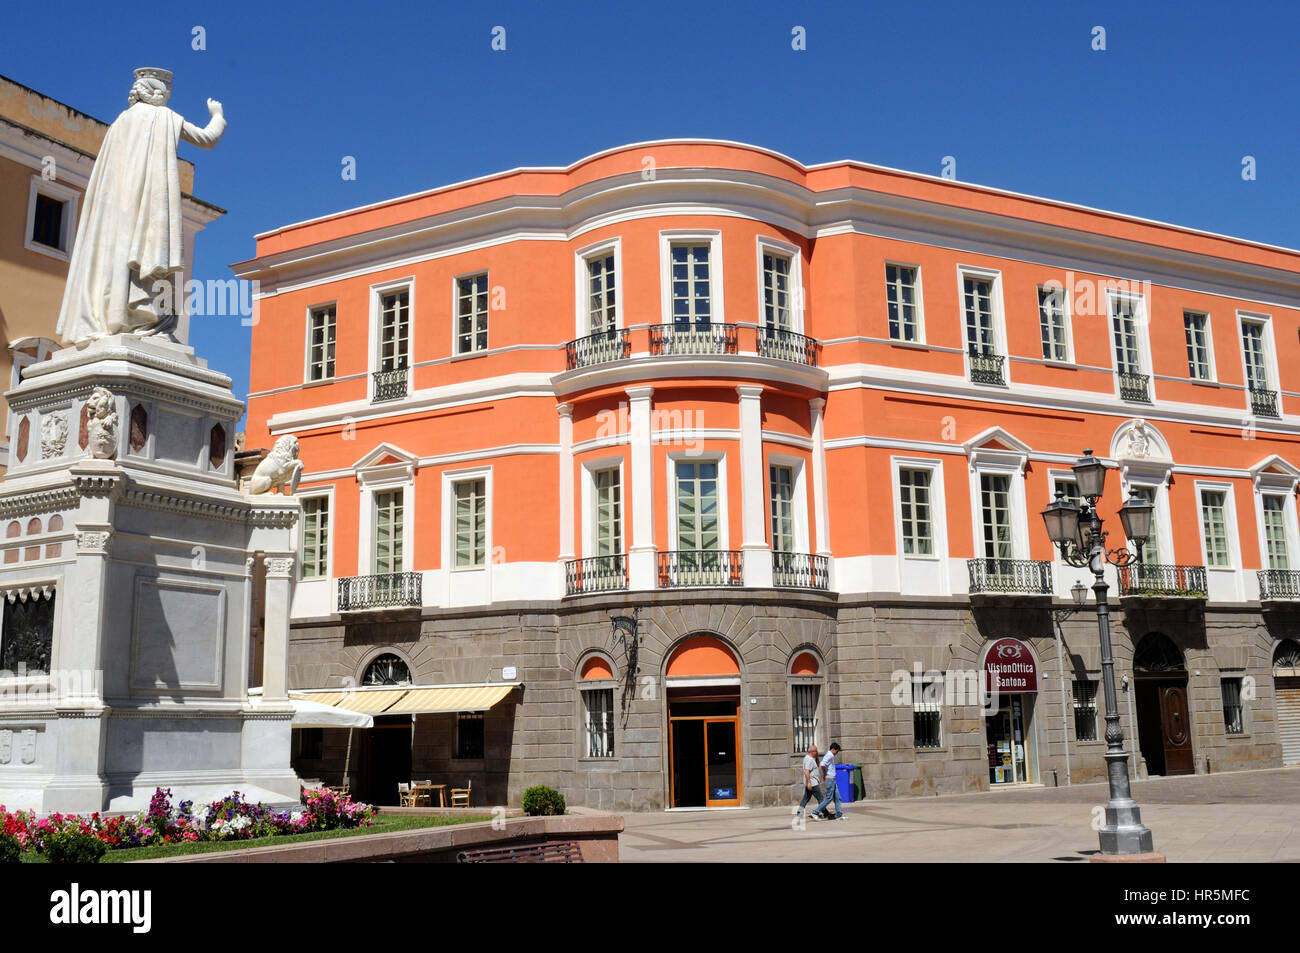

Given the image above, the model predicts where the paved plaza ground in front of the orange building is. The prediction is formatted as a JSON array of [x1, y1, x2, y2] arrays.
[[620, 767, 1300, 863]]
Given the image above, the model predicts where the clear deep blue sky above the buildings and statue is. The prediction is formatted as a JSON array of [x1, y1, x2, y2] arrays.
[[0, 0, 1300, 397]]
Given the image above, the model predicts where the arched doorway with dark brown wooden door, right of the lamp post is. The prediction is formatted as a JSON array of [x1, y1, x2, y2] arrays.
[[1134, 632, 1196, 775]]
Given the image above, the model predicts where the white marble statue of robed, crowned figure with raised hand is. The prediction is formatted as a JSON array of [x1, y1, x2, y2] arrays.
[[59, 68, 226, 347]]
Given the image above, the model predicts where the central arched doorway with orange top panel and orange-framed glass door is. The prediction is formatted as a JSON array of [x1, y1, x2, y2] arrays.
[[666, 636, 744, 807]]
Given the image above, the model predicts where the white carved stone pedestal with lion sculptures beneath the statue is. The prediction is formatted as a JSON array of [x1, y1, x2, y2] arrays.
[[0, 335, 299, 811]]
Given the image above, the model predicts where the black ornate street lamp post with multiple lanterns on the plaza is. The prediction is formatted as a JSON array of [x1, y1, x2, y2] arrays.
[[1043, 450, 1153, 854]]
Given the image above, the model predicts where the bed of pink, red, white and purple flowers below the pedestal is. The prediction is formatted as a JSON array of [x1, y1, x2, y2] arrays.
[[0, 788, 380, 863]]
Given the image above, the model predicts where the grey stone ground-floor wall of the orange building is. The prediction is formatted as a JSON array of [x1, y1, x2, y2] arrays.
[[290, 590, 1300, 811]]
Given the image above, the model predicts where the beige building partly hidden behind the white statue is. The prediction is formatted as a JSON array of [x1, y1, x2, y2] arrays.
[[0, 75, 224, 472]]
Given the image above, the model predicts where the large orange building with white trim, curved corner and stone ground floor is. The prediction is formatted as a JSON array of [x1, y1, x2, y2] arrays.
[[235, 142, 1300, 809]]
